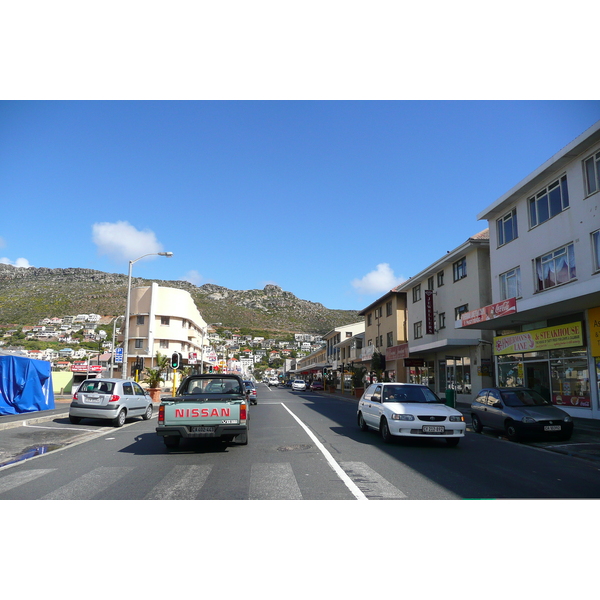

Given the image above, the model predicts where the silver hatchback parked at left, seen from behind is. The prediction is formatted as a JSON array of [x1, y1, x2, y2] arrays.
[[69, 379, 152, 427]]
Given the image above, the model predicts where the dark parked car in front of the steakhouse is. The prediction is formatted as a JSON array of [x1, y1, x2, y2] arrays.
[[471, 387, 573, 441]]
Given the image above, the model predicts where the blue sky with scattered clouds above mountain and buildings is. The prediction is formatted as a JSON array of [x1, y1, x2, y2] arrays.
[[0, 100, 600, 309]]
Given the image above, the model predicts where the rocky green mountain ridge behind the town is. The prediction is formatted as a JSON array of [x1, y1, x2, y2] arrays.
[[0, 264, 360, 334]]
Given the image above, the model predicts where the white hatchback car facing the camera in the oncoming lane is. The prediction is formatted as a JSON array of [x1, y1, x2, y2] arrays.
[[357, 383, 466, 446]]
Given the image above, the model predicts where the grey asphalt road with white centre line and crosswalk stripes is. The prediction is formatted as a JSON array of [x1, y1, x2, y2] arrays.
[[0, 385, 600, 500]]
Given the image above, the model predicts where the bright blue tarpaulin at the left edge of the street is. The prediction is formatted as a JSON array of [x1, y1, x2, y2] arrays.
[[0, 356, 54, 415]]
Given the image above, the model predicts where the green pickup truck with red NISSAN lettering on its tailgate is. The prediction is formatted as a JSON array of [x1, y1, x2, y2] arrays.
[[156, 374, 250, 448]]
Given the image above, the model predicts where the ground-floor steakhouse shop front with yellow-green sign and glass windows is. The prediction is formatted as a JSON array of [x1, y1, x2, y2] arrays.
[[493, 321, 600, 418]]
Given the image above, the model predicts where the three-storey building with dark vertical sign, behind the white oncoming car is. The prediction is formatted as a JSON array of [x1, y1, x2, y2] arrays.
[[392, 229, 492, 402]]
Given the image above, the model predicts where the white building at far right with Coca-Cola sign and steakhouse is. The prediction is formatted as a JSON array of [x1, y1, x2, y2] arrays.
[[457, 121, 600, 419]]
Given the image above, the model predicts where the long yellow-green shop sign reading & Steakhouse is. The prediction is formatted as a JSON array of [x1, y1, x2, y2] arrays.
[[494, 322, 583, 356]]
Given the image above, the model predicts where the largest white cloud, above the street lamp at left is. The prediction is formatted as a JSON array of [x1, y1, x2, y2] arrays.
[[92, 221, 163, 262]]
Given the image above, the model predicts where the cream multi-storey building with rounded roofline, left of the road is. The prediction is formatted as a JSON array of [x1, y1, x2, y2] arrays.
[[120, 283, 208, 376]]
